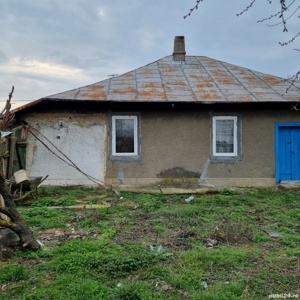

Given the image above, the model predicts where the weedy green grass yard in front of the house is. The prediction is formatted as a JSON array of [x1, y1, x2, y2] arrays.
[[0, 189, 300, 300]]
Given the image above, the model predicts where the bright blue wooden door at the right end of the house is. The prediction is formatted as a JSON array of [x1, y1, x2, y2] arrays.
[[276, 126, 300, 182]]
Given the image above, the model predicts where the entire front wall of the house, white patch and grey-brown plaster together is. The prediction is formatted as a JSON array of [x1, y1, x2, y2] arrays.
[[24, 104, 300, 186]]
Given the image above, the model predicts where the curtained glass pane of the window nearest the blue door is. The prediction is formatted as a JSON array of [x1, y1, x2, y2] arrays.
[[216, 120, 234, 153]]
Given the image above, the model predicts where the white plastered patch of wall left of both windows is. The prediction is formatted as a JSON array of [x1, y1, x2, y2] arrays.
[[26, 117, 106, 186]]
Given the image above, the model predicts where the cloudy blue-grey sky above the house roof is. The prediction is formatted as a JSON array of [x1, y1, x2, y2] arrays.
[[0, 0, 300, 103]]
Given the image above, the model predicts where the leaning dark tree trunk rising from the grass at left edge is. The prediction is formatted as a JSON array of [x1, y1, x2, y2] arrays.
[[0, 174, 40, 250]]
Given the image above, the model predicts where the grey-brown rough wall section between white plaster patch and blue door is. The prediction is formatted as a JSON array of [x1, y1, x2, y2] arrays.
[[106, 109, 300, 186]]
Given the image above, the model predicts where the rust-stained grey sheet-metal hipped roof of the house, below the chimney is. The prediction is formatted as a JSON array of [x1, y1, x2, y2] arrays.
[[12, 55, 300, 109]]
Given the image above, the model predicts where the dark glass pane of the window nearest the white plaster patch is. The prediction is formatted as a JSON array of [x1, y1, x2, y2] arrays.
[[116, 119, 134, 153]]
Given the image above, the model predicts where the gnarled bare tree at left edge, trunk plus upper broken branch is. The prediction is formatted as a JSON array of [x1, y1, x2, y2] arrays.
[[0, 87, 40, 250]]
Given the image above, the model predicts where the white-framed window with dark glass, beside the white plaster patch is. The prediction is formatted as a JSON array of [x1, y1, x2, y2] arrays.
[[112, 116, 138, 156]]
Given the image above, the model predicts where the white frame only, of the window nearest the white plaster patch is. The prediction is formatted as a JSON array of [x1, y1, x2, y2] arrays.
[[112, 116, 138, 156]]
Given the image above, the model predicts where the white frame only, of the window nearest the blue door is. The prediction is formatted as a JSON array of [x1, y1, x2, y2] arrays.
[[212, 116, 238, 157]]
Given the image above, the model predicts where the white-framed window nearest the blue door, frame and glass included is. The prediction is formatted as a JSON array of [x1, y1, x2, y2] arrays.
[[212, 116, 238, 157]]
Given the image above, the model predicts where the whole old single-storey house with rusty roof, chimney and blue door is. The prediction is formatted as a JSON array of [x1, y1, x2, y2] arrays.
[[11, 37, 300, 186]]
